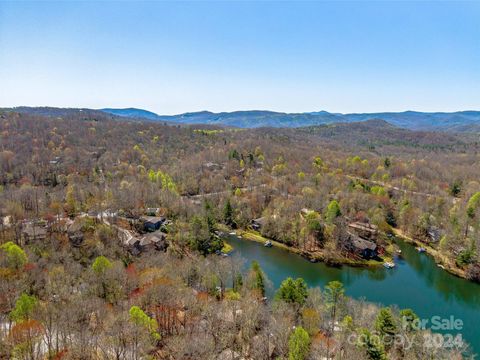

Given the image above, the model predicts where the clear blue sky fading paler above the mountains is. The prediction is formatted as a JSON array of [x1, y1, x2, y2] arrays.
[[0, 0, 480, 114]]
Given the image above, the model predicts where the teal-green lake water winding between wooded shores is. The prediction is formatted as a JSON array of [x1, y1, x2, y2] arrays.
[[228, 236, 480, 353]]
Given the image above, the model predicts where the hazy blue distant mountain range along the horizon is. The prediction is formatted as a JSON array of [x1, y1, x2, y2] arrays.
[[100, 108, 480, 132]]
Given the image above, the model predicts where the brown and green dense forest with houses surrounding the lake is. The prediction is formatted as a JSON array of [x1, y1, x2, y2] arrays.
[[0, 109, 480, 360]]
